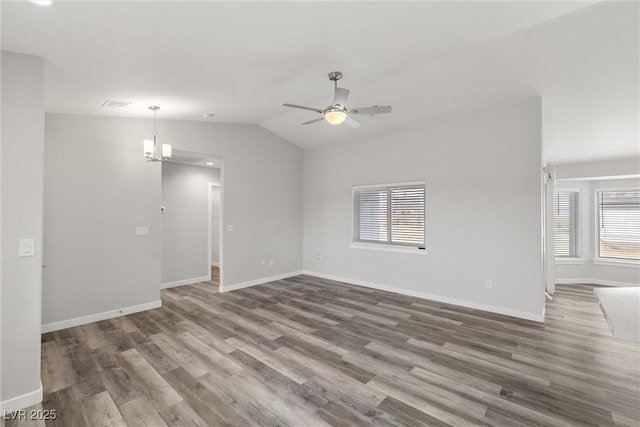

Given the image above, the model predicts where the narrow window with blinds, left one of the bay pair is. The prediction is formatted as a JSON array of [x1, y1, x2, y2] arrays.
[[553, 191, 578, 258]]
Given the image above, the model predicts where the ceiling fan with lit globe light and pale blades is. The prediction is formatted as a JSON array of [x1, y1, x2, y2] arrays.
[[282, 71, 391, 128]]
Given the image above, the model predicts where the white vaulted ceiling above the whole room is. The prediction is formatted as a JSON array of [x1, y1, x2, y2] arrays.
[[1, 0, 640, 163]]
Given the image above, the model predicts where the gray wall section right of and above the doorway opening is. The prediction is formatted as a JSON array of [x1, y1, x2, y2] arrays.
[[158, 120, 302, 290]]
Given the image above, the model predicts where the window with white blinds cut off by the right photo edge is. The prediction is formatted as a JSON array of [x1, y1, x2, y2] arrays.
[[597, 190, 640, 260]]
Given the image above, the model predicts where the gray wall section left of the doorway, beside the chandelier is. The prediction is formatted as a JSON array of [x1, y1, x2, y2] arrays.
[[42, 114, 161, 330]]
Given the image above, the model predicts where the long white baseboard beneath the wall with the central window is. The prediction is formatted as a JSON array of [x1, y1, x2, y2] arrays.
[[302, 270, 544, 323]]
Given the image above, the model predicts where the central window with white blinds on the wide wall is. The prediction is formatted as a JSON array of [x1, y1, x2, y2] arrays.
[[353, 183, 425, 249]]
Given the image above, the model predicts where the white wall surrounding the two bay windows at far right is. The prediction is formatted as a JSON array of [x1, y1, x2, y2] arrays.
[[555, 176, 640, 286]]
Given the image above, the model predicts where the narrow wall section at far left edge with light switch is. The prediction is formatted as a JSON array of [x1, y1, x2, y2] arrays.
[[0, 52, 44, 411]]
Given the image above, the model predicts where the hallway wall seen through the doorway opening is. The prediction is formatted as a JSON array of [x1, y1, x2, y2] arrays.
[[161, 163, 220, 287]]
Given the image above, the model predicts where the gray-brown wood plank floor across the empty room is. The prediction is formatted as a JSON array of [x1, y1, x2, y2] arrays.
[[6, 276, 640, 427]]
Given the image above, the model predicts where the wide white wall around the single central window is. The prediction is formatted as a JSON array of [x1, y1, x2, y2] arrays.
[[304, 101, 544, 320]]
